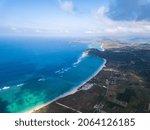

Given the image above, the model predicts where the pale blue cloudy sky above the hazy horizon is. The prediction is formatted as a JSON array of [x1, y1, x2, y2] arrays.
[[0, 0, 150, 36]]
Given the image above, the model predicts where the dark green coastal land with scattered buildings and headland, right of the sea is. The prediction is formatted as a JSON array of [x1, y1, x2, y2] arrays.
[[34, 40, 150, 113]]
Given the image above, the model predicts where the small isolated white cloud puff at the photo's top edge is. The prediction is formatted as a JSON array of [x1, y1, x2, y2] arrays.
[[59, 0, 74, 13]]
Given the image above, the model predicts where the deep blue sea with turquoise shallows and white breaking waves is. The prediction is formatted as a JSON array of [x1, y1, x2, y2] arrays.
[[0, 38, 105, 113]]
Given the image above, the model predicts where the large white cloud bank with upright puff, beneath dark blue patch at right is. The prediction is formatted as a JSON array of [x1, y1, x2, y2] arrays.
[[91, 6, 150, 35]]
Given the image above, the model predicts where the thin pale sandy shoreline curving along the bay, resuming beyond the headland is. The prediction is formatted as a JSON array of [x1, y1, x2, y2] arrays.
[[27, 43, 107, 113]]
